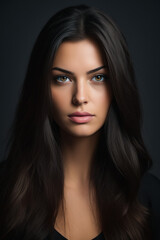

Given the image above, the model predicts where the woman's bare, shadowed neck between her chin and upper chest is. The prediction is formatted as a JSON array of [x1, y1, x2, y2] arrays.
[[61, 131, 100, 187]]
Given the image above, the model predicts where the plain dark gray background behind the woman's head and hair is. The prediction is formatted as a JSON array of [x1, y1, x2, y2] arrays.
[[0, 0, 160, 178]]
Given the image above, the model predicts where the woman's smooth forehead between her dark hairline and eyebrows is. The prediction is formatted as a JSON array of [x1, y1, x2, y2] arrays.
[[53, 39, 104, 71]]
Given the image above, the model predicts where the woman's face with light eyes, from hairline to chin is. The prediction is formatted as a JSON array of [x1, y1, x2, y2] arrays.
[[51, 39, 112, 137]]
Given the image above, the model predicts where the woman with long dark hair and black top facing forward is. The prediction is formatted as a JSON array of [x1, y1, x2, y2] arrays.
[[0, 5, 155, 240]]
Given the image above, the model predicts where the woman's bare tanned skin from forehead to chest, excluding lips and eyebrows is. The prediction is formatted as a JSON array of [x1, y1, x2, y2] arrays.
[[51, 39, 112, 240]]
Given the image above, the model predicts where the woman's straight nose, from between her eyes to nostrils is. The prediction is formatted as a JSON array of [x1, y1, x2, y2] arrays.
[[72, 79, 88, 105]]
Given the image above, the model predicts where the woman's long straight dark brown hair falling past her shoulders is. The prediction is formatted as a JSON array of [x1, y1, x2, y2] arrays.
[[0, 5, 152, 240]]
